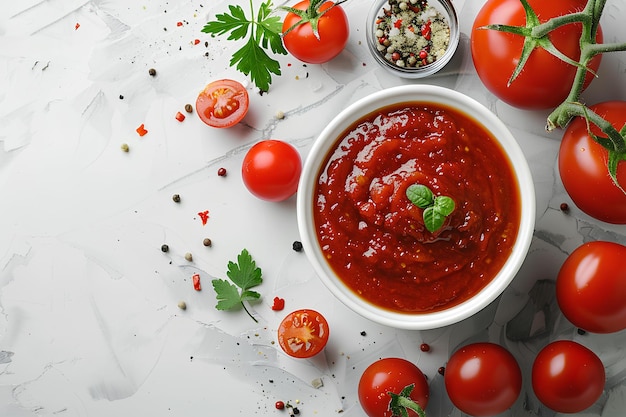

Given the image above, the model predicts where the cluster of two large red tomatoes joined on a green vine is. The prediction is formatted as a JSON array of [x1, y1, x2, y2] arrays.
[[471, 0, 626, 224]]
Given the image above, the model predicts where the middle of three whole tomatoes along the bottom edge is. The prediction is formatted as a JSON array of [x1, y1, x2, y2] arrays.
[[444, 343, 522, 416]]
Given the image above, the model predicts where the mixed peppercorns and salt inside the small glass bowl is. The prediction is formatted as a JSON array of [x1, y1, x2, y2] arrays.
[[374, 0, 450, 68]]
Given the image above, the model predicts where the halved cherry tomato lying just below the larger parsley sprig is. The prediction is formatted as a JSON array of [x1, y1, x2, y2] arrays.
[[196, 80, 250, 127]]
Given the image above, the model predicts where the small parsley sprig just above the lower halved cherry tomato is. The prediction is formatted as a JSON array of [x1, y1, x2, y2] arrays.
[[211, 249, 263, 323]]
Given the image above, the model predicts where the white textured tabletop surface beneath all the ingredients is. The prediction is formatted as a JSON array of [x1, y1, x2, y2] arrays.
[[0, 0, 626, 417]]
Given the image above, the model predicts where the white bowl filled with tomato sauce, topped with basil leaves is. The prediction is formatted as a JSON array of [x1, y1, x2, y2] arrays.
[[297, 85, 535, 330]]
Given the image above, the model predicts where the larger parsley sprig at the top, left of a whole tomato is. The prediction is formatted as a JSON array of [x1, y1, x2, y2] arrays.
[[202, 0, 287, 92]]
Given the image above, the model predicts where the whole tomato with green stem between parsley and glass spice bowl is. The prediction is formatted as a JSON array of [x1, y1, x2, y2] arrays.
[[283, 0, 350, 64]]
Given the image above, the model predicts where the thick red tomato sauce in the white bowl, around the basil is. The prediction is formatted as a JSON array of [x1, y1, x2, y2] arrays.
[[314, 103, 520, 313]]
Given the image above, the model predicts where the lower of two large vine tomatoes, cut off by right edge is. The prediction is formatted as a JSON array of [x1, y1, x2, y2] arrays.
[[559, 101, 626, 224]]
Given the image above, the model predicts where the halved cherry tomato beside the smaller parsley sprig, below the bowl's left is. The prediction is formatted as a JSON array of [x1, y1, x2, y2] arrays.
[[278, 309, 329, 358]]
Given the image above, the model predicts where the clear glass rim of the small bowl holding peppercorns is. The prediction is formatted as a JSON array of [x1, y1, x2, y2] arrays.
[[365, 0, 461, 79]]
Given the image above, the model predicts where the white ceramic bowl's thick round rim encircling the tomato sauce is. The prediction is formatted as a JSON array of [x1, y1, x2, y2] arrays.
[[297, 85, 535, 330]]
